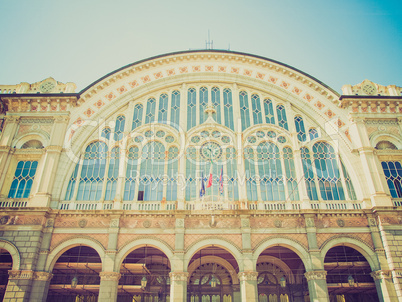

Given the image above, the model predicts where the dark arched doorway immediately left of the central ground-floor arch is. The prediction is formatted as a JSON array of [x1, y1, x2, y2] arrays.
[[117, 245, 171, 302]]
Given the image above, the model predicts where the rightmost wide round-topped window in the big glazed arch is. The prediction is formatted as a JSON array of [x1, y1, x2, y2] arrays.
[[313, 142, 345, 200]]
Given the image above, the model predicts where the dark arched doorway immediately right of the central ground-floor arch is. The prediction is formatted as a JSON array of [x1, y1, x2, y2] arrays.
[[257, 246, 308, 302]]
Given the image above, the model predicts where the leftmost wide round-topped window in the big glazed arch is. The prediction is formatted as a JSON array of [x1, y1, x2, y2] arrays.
[[77, 142, 108, 200]]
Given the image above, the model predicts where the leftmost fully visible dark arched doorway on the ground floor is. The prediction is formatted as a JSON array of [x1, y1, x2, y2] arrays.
[[47, 245, 102, 302]]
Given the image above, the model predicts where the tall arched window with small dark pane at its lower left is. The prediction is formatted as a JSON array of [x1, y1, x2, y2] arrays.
[[138, 141, 165, 201]]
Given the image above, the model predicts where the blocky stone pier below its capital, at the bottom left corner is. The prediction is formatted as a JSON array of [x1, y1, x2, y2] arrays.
[[3, 270, 34, 302]]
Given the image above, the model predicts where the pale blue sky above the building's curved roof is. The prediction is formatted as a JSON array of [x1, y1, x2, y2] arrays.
[[0, 0, 402, 92]]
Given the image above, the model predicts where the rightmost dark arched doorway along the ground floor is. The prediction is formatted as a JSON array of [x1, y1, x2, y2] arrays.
[[324, 245, 379, 302]]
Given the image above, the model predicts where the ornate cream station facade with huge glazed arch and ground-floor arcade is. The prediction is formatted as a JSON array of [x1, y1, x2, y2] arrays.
[[0, 50, 402, 302]]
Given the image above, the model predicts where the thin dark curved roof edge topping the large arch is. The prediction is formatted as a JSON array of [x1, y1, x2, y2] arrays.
[[78, 49, 340, 96]]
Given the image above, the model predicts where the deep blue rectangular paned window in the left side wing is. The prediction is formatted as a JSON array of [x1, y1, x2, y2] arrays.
[[8, 161, 38, 198]]
